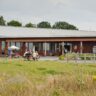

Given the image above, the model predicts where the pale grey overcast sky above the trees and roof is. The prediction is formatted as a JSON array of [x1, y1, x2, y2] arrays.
[[0, 0, 96, 31]]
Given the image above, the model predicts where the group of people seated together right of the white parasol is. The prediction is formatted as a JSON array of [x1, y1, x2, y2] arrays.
[[24, 50, 40, 61]]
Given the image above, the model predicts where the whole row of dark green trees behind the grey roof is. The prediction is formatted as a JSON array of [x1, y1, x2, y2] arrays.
[[0, 16, 78, 30]]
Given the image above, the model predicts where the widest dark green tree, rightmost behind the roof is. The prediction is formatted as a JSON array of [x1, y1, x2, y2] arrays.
[[53, 21, 78, 30]]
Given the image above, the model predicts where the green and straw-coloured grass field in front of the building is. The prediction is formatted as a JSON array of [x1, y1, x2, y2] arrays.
[[0, 59, 96, 96]]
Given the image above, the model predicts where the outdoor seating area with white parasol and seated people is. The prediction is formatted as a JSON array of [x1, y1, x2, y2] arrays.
[[1, 45, 40, 61]]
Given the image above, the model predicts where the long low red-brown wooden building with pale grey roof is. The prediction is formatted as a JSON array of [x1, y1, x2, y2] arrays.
[[0, 26, 96, 56]]
